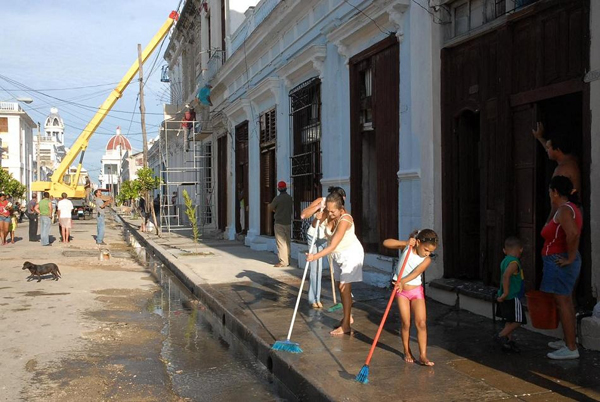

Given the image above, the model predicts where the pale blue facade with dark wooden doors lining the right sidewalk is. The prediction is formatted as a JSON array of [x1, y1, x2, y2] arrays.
[[166, 0, 600, 348]]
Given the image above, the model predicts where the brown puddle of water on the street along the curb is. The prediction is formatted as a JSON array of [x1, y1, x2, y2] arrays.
[[140, 253, 295, 401]]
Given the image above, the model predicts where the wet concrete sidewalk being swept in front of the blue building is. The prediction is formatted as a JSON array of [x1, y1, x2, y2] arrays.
[[124, 218, 600, 401]]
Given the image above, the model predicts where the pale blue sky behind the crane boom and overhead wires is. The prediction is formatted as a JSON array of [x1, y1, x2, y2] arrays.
[[0, 0, 180, 183]]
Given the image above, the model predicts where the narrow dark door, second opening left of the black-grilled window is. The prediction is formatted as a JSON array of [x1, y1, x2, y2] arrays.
[[235, 121, 250, 234]]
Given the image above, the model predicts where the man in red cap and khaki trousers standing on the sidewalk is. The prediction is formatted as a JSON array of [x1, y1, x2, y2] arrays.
[[269, 181, 292, 268]]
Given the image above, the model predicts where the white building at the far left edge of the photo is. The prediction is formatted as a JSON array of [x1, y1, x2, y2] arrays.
[[0, 102, 37, 196]]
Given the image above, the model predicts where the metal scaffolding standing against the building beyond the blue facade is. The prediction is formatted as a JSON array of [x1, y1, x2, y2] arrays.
[[157, 115, 214, 235]]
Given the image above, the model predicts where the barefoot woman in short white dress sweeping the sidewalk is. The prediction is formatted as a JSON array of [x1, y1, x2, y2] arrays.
[[306, 193, 365, 335]]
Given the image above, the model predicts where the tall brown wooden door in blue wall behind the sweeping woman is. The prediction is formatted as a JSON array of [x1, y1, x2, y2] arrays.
[[350, 37, 400, 255]]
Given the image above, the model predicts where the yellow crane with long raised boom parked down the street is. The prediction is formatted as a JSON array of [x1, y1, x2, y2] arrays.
[[31, 11, 179, 199]]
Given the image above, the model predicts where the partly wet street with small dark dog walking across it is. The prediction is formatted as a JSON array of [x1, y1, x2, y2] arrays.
[[0, 212, 290, 401]]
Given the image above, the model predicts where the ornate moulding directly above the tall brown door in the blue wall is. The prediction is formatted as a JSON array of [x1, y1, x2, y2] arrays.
[[327, 0, 410, 63]]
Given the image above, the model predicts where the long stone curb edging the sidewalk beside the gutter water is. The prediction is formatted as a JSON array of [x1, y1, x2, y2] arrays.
[[115, 214, 333, 402]]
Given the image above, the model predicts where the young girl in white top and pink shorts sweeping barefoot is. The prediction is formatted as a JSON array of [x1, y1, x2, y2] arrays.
[[383, 229, 438, 366]]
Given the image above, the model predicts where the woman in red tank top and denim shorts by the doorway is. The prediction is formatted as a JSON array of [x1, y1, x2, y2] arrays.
[[540, 176, 583, 360]]
